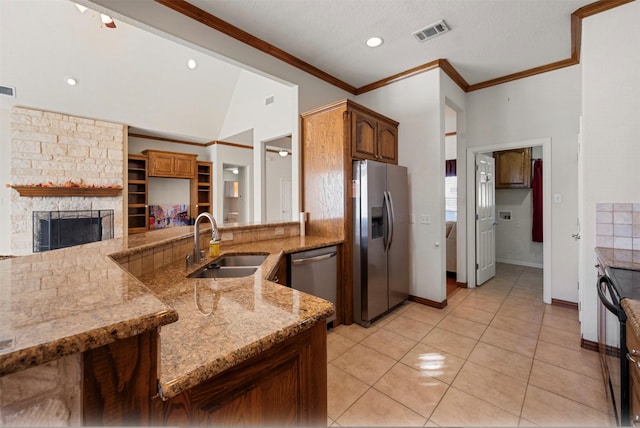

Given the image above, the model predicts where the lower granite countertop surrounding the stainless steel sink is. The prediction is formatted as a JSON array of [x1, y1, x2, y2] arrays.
[[140, 236, 341, 398]]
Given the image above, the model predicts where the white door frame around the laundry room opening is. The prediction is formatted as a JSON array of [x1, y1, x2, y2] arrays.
[[466, 138, 552, 304]]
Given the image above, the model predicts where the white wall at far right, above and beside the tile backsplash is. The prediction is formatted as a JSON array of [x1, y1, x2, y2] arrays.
[[580, 1, 640, 341]]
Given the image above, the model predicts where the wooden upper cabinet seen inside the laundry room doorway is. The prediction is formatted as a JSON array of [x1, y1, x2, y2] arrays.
[[493, 147, 531, 189]]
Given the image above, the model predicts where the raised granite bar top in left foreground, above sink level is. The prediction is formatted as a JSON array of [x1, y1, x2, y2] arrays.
[[0, 238, 178, 376]]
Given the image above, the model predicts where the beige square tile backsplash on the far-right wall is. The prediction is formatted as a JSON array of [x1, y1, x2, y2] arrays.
[[596, 203, 640, 250]]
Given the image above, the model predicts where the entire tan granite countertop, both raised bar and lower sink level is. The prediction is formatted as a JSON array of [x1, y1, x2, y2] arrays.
[[0, 226, 342, 398]]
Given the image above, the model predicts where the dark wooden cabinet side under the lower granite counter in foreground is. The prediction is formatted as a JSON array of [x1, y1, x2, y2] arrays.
[[152, 322, 327, 426]]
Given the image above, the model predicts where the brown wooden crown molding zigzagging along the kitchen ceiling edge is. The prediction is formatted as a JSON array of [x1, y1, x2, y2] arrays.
[[155, 0, 635, 95]]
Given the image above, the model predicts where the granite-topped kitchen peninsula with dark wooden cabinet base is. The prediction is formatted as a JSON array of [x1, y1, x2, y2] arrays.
[[0, 226, 340, 425]]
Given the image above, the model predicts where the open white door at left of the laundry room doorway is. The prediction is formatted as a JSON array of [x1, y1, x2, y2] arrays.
[[476, 153, 496, 285]]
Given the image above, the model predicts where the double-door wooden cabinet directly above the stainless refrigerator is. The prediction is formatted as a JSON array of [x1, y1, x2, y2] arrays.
[[348, 105, 398, 164]]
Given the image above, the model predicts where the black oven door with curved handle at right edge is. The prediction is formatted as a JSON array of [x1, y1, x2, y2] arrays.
[[597, 275, 629, 426]]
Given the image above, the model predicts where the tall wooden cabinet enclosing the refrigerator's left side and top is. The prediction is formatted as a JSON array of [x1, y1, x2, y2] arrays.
[[301, 99, 398, 324]]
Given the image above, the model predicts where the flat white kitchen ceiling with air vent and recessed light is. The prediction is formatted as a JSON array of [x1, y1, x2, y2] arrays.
[[181, 0, 594, 87]]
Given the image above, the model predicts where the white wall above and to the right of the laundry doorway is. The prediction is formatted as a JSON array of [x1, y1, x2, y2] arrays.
[[458, 65, 581, 302]]
